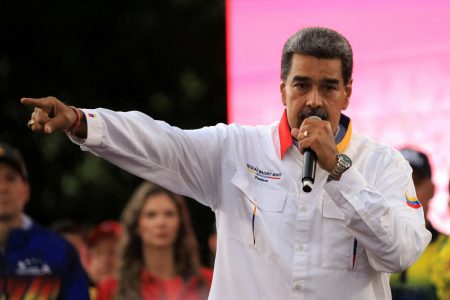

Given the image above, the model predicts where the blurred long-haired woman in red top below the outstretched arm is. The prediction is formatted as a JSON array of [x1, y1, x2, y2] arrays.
[[97, 182, 212, 300]]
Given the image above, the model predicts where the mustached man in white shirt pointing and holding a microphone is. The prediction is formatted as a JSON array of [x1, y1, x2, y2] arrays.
[[22, 28, 431, 299]]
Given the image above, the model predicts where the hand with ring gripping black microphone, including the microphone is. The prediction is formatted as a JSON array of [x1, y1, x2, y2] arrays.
[[291, 116, 337, 193]]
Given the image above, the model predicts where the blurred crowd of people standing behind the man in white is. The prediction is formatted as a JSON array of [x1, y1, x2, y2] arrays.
[[0, 144, 450, 300]]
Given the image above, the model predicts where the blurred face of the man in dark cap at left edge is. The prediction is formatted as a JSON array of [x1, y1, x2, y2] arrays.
[[0, 162, 29, 221]]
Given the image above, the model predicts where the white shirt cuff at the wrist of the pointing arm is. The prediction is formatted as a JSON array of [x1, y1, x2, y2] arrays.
[[67, 109, 103, 146]]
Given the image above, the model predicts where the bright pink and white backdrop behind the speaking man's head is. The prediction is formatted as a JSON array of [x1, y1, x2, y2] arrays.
[[226, 0, 450, 233]]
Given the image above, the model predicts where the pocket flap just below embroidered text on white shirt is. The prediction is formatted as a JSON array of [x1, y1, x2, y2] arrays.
[[231, 171, 287, 212]]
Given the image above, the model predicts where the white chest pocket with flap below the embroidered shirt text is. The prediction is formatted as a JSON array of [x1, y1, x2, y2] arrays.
[[231, 171, 287, 251]]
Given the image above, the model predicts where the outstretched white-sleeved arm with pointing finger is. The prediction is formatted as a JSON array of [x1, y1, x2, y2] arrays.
[[21, 97, 227, 208]]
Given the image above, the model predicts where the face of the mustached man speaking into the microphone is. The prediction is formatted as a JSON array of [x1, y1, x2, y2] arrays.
[[280, 54, 352, 132]]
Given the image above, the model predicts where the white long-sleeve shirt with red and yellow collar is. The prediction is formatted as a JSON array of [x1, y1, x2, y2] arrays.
[[71, 109, 431, 300]]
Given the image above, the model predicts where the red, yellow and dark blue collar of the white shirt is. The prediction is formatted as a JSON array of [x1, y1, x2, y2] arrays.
[[278, 110, 352, 159]]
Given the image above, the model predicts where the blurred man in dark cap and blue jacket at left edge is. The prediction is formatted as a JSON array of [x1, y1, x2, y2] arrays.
[[0, 143, 89, 300]]
